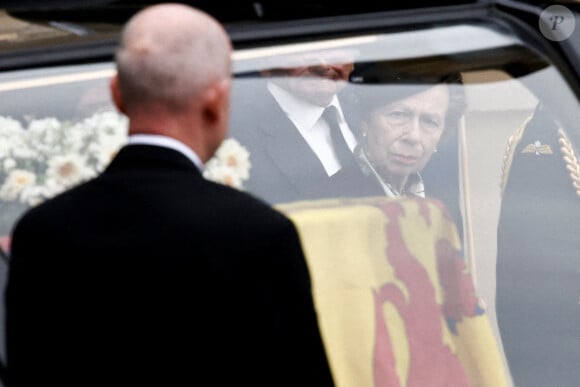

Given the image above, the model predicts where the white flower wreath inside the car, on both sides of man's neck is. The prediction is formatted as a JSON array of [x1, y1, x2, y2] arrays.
[[0, 111, 250, 211]]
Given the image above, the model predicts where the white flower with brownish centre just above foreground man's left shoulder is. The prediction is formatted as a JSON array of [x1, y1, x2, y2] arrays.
[[46, 154, 94, 187]]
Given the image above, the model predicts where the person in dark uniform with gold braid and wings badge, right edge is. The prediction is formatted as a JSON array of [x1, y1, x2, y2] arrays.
[[496, 105, 580, 386]]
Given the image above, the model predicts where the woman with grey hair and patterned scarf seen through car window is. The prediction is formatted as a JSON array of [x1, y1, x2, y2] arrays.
[[352, 67, 466, 235]]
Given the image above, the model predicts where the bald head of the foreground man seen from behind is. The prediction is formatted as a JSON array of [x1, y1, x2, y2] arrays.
[[111, 3, 232, 162]]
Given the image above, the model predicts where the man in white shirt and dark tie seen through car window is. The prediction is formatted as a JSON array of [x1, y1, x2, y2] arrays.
[[231, 49, 383, 203]]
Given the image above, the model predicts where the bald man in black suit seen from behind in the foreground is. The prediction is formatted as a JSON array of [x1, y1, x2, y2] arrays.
[[6, 4, 333, 387]]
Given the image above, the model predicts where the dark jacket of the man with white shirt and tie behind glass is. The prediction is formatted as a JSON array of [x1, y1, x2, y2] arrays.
[[230, 79, 384, 203]]
